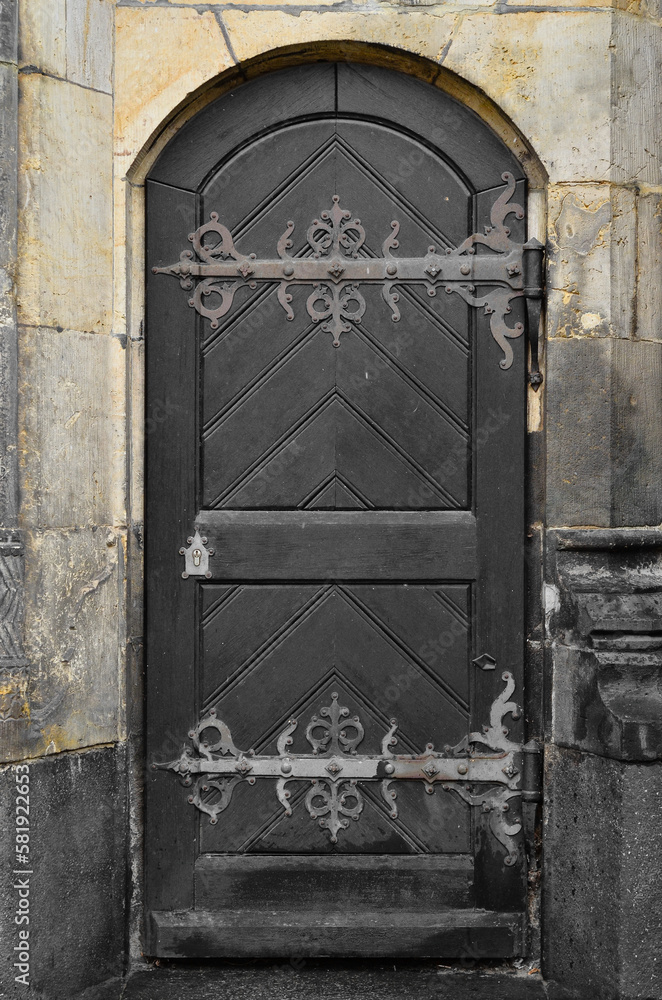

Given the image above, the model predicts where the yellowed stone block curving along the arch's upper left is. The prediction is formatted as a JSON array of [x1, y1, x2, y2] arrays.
[[115, 7, 234, 173]]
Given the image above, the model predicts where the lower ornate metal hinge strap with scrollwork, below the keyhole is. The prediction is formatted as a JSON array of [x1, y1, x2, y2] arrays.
[[152, 671, 536, 865]]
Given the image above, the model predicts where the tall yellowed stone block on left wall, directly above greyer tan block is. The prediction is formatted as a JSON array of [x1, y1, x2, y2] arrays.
[[18, 74, 112, 332]]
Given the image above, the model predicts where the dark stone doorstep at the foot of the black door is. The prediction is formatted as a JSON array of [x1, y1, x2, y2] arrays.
[[76, 961, 589, 1000]]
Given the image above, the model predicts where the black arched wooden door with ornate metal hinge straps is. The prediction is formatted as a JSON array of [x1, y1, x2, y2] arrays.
[[146, 64, 525, 957]]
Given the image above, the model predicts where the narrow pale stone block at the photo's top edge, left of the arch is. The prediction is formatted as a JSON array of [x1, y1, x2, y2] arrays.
[[66, 0, 115, 94]]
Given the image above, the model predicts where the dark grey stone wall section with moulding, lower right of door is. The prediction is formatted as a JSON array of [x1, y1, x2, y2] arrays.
[[543, 529, 662, 1000]]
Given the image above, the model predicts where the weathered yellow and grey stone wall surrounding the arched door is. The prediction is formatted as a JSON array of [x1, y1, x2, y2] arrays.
[[0, 0, 662, 998]]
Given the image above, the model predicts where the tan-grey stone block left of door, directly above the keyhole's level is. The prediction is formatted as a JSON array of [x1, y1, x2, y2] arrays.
[[19, 327, 126, 528]]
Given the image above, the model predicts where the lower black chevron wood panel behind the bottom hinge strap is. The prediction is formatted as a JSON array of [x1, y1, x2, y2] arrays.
[[200, 583, 470, 854]]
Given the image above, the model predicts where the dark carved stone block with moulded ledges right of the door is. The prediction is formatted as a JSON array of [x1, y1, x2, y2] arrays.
[[547, 529, 662, 761]]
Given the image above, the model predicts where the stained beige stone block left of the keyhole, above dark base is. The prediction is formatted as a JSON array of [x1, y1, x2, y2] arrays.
[[14, 528, 126, 756]]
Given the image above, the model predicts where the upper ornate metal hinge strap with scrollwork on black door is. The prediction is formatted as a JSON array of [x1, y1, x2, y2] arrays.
[[152, 173, 544, 389]]
